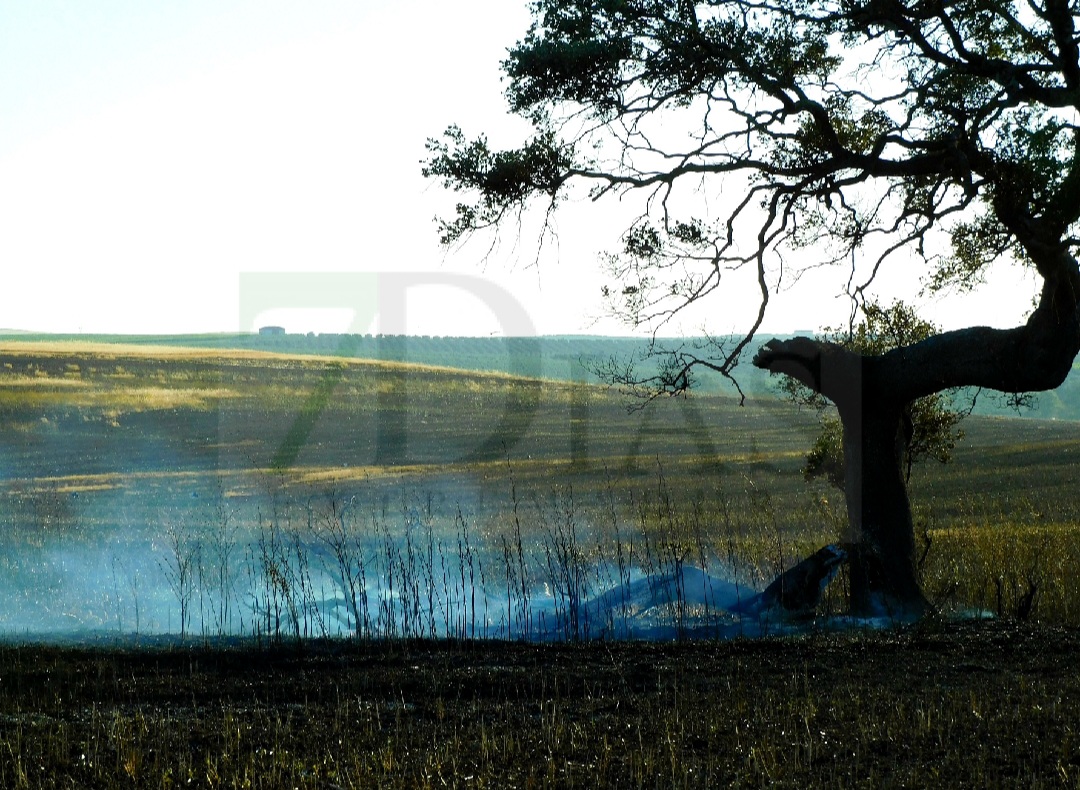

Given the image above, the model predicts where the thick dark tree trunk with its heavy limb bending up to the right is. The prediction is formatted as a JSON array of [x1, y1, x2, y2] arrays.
[[754, 259, 1080, 618]]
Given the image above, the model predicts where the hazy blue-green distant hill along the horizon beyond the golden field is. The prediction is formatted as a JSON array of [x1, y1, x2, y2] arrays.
[[8, 330, 1080, 419]]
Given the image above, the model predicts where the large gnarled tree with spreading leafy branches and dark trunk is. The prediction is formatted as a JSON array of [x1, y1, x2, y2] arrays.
[[423, 0, 1080, 616]]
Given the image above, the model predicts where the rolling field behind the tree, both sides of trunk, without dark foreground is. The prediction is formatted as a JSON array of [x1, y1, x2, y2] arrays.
[[0, 342, 1080, 633]]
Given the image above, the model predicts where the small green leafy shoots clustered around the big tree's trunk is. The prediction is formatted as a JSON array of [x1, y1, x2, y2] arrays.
[[780, 302, 964, 491]]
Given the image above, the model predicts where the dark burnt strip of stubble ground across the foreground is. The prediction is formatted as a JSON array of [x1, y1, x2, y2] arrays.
[[0, 621, 1080, 788]]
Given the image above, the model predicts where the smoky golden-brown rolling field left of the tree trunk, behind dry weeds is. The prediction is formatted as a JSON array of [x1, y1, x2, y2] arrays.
[[0, 344, 813, 633]]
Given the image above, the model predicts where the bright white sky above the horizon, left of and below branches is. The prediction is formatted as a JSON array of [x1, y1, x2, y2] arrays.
[[0, 0, 1035, 335]]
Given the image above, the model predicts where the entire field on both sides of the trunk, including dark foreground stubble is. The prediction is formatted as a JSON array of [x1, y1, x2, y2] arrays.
[[0, 342, 1080, 788]]
